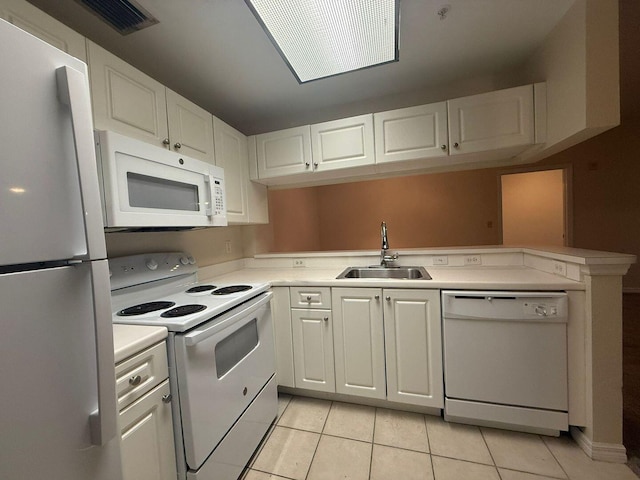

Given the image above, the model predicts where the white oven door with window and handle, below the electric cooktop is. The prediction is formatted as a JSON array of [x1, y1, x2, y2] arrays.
[[175, 292, 275, 470]]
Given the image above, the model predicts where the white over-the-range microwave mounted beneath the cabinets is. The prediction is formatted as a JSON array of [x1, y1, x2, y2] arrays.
[[95, 130, 227, 230]]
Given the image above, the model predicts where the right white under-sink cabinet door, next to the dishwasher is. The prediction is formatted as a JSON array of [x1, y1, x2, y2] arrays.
[[383, 289, 444, 408]]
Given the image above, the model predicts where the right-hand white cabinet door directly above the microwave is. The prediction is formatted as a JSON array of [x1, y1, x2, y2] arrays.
[[166, 88, 214, 163]]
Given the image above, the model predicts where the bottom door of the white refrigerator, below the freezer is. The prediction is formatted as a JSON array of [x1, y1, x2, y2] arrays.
[[0, 260, 122, 480]]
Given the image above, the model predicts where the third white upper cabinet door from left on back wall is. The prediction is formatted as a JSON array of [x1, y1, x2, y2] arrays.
[[373, 102, 448, 163]]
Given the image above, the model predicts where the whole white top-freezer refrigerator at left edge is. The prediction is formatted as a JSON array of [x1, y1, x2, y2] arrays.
[[0, 20, 122, 480]]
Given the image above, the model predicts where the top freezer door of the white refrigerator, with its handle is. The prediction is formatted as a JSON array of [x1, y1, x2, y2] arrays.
[[0, 20, 106, 266]]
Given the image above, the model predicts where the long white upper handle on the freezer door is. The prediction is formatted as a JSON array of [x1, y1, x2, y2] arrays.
[[56, 66, 109, 260]]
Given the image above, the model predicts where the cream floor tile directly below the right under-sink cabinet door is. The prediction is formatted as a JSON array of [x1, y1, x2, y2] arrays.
[[373, 408, 429, 453]]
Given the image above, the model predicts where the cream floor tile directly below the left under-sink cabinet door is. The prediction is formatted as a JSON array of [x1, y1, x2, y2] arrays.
[[322, 402, 376, 442]]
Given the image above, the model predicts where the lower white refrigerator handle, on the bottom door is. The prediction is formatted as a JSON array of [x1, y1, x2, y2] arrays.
[[89, 260, 118, 445]]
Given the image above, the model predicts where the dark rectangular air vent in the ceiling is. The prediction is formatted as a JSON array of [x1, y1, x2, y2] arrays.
[[76, 0, 159, 35]]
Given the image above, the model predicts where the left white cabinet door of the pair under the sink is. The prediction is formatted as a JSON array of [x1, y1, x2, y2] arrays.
[[331, 288, 387, 399]]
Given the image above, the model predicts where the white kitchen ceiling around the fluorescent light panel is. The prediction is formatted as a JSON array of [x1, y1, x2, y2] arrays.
[[29, 0, 574, 134]]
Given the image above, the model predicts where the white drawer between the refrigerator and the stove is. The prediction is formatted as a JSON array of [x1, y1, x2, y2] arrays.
[[116, 342, 169, 410]]
